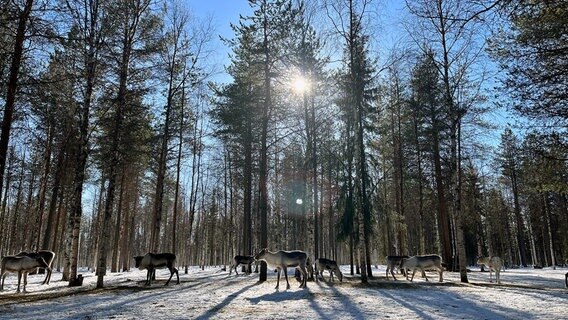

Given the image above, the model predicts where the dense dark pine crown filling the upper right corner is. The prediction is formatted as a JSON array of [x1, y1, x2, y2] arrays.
[[490, 0, 568, 126]]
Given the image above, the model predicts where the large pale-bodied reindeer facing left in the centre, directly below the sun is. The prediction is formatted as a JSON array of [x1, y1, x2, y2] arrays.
[[254, 248, 308, 289]]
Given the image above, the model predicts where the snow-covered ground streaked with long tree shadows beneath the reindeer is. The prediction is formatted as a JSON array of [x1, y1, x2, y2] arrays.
[[0, 266, 568, 320]]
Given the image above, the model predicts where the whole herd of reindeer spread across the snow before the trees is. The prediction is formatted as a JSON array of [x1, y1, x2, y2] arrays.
[[0, 248, 568, 293]]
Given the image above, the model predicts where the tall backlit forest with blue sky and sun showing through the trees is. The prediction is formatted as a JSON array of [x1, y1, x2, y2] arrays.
[[0, 0, 568, 287]]
